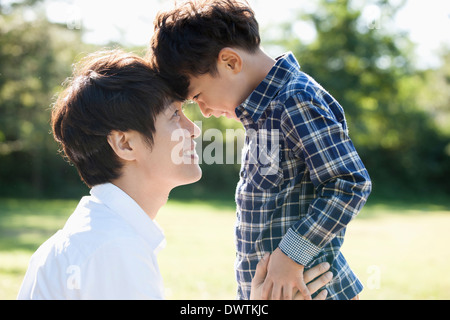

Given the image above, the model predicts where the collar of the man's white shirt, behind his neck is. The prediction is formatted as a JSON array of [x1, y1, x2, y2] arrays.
[[90, 183, 166, 254]]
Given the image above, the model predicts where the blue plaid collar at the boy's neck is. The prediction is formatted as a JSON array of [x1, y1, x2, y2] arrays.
[[236, 52, 300, 123]]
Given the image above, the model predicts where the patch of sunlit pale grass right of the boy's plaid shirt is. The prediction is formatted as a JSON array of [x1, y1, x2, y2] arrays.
[[342, 204, 450, 300]]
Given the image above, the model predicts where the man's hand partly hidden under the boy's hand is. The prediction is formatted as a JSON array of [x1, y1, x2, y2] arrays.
[[250, 253, 333, 300]]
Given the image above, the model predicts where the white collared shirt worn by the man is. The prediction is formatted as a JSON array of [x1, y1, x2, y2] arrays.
[[18, 183, 165, 299]]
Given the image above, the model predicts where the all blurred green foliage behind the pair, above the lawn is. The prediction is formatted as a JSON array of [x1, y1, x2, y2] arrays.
[[0, 0, 450, 197]]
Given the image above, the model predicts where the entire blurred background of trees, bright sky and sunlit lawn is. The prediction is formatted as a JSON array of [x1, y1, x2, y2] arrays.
[[0, 0, 450, 299]]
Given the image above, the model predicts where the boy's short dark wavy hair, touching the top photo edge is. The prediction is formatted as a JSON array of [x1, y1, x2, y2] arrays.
[[149, 0, 261, 99]]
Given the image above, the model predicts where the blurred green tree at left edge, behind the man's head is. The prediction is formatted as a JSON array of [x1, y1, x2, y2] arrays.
[[0, 4, 93, 195]]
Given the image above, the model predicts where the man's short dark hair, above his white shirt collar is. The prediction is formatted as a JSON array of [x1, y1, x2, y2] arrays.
[[51, 50, 173, 187]]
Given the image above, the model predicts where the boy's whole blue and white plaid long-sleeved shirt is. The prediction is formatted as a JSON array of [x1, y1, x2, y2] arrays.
[[235, 53, 371, 299]]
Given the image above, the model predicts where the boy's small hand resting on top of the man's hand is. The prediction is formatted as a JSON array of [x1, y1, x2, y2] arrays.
[[261, 248, 311, 300]]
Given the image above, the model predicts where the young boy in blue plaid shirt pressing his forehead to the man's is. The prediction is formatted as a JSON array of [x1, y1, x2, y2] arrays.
[[150, 0, 371, 299]]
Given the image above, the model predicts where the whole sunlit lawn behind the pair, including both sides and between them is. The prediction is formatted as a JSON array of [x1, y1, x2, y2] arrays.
[[0, 195, 450, 299]]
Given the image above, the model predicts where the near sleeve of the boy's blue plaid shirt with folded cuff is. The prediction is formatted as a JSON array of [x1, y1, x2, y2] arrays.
[[279, 91, 371, 266]]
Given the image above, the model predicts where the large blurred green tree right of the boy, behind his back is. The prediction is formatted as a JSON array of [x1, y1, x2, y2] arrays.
[[266, 0, 450, 193]]
